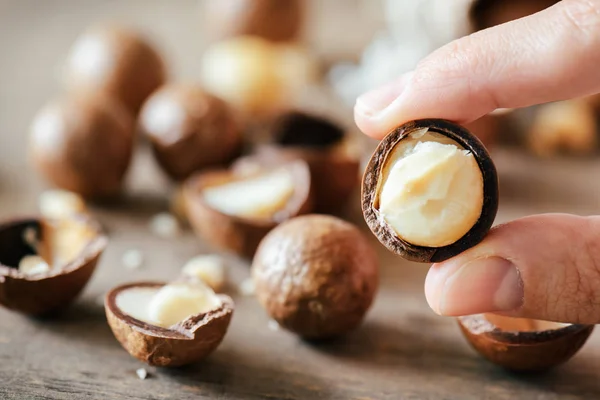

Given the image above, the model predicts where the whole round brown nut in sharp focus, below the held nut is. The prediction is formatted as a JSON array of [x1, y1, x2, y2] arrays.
[[252, 215, 379, 339]]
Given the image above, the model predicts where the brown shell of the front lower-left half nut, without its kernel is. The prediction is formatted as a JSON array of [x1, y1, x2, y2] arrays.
[[104, 282, 234, 367]]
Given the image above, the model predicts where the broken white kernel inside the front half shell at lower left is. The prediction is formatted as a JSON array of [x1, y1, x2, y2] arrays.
[[116, 283, 221, 328]]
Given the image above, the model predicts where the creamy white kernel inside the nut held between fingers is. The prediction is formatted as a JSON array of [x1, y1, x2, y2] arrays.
[[378, 129, 483, 247]]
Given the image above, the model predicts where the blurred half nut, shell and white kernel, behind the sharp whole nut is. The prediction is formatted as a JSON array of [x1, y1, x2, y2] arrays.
[[184, 160, 312, 257]]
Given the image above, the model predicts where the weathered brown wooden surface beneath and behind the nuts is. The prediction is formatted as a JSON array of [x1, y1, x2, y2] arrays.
[[0, 0, 600, 400]]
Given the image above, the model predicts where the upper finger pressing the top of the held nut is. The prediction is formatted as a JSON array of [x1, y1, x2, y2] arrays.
[[354, 0, 600, 138]]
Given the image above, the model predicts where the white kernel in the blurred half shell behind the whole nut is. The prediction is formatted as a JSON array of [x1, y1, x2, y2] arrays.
[[203, 168, 294, 219]]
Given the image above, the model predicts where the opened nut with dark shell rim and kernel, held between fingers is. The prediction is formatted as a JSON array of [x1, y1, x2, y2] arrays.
[[361, 119, 498, 262]]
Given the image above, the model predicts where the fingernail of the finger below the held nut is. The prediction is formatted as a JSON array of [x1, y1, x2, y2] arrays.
[[436, 257, 524, 315]]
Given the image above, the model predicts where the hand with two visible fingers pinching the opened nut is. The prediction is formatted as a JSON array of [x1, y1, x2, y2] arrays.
[[354, 0, 600, 324]]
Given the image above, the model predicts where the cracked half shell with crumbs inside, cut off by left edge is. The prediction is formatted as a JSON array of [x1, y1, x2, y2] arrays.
[[0, 217, 107, 316]]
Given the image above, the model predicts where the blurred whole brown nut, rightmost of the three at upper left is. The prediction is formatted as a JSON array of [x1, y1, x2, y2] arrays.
[[139, 84, 242, 180]]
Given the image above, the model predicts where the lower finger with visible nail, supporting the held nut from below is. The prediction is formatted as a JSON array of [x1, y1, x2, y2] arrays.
[[425, 214, 600, 324]]
